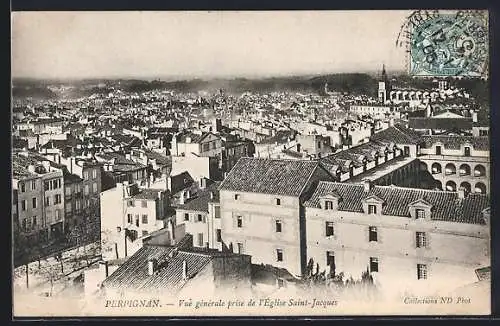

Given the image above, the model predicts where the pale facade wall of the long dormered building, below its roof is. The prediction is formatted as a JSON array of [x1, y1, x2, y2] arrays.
[[306, 207, 490, 296]]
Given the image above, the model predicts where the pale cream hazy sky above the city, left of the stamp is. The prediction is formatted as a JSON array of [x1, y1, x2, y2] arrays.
[[11, 11, 409, 79]]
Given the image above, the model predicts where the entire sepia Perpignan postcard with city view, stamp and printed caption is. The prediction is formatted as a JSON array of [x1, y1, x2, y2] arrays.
[[10, 10, 492, 318]]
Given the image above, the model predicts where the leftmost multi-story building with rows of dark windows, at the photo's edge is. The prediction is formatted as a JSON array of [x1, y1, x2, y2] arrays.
[[12, 152, 64, 244]]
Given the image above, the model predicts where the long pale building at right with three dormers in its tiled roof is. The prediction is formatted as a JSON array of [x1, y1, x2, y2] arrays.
[[305, 181, 490, 291]]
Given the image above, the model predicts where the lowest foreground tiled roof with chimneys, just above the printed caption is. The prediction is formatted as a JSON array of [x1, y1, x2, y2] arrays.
[[103, 245, 212, 294]]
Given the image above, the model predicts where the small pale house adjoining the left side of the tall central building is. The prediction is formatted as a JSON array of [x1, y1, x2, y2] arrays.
[[176, 180, 222, 250]]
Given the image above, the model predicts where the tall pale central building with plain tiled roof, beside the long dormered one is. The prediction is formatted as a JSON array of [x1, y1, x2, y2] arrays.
[[219, 158, 334, 275]]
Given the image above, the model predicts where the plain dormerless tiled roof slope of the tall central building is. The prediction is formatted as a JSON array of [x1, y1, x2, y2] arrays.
[[219, 157, 319, 196]]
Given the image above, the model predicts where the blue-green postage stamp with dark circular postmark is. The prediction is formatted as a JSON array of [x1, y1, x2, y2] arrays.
[[407, 11, 489, 78]]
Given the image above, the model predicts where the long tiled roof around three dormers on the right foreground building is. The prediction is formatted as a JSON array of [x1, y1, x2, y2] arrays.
[[305, 181, 490, 224]]
